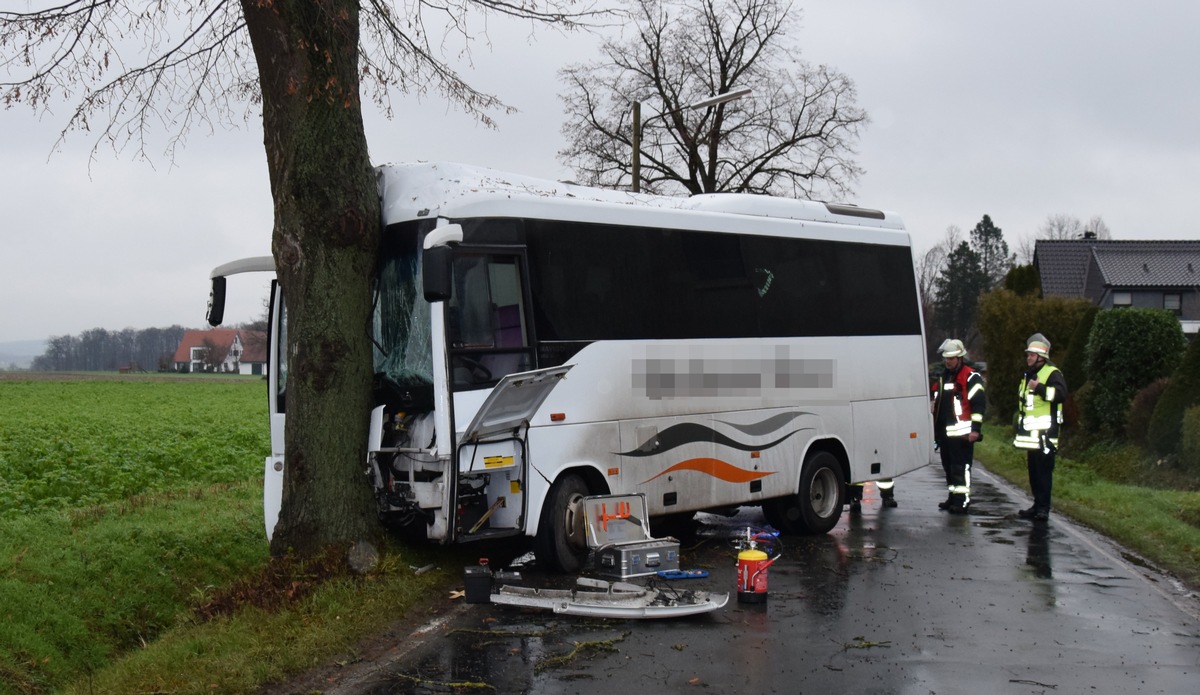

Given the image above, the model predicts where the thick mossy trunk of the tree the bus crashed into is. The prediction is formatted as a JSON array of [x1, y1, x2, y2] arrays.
[[242, 0, 380, 556]]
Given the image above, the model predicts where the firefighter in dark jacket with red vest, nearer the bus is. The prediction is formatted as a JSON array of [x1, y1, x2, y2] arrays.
[[930, 338, 988, 514]]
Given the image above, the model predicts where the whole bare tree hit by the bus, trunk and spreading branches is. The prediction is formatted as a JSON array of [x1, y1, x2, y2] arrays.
[[0, 0, 593, 556]]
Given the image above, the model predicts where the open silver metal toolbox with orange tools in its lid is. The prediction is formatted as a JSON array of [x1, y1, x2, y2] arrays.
[[583, 495, 679, 579]]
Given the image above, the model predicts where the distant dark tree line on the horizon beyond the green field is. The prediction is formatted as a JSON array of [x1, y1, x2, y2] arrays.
[[30, 325, 188, 372]]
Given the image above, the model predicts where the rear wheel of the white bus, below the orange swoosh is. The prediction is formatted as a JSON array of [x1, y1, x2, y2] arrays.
[[762, 451, 846, 535]]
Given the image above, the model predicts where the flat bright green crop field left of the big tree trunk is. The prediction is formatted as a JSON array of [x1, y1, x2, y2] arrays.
[[0, 378, 270, 519]]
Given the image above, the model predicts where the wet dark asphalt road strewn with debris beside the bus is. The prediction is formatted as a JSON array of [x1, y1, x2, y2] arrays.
[[314, 466, 1200, 695]]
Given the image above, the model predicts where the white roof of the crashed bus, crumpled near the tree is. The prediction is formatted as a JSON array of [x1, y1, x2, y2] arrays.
[[378, 162, 910, 246]]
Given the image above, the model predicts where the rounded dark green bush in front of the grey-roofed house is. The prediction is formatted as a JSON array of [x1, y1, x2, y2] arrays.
[[1084, 308, 1187, 437]]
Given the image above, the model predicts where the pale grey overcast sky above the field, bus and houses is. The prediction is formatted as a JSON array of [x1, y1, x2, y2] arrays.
[[0, 0, 1200, 342]]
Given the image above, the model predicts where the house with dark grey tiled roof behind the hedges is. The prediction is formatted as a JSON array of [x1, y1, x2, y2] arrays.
[[1033, 238, 1200, 337]]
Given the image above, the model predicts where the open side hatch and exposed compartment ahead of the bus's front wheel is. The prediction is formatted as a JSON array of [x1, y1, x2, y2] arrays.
[[454, 365, 571, 540]]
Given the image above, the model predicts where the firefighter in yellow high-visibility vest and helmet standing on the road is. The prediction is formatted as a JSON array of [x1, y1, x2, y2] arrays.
[[1013, 332, 1067, 521]]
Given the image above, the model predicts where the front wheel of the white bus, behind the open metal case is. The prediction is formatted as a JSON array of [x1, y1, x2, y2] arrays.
[[533, 473, 589, 574]]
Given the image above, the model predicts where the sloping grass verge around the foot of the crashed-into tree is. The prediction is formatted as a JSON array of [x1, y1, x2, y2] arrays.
[[0, 480, 462, 695]]
